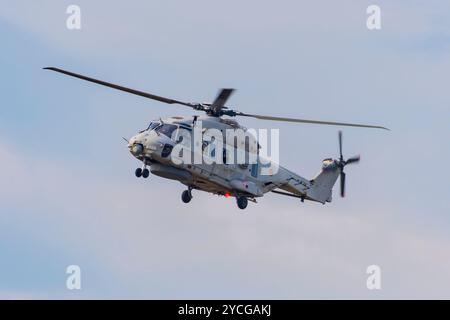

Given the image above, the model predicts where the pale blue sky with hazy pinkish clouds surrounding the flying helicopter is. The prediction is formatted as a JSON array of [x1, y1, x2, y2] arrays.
[[0, 0, 450, 298]]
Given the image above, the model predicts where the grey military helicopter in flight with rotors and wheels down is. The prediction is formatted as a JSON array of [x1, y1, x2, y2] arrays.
[[44, 67, 389, 209]]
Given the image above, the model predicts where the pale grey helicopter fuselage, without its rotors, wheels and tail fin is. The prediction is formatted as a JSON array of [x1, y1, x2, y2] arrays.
[[128, 116, 331, 202]]
